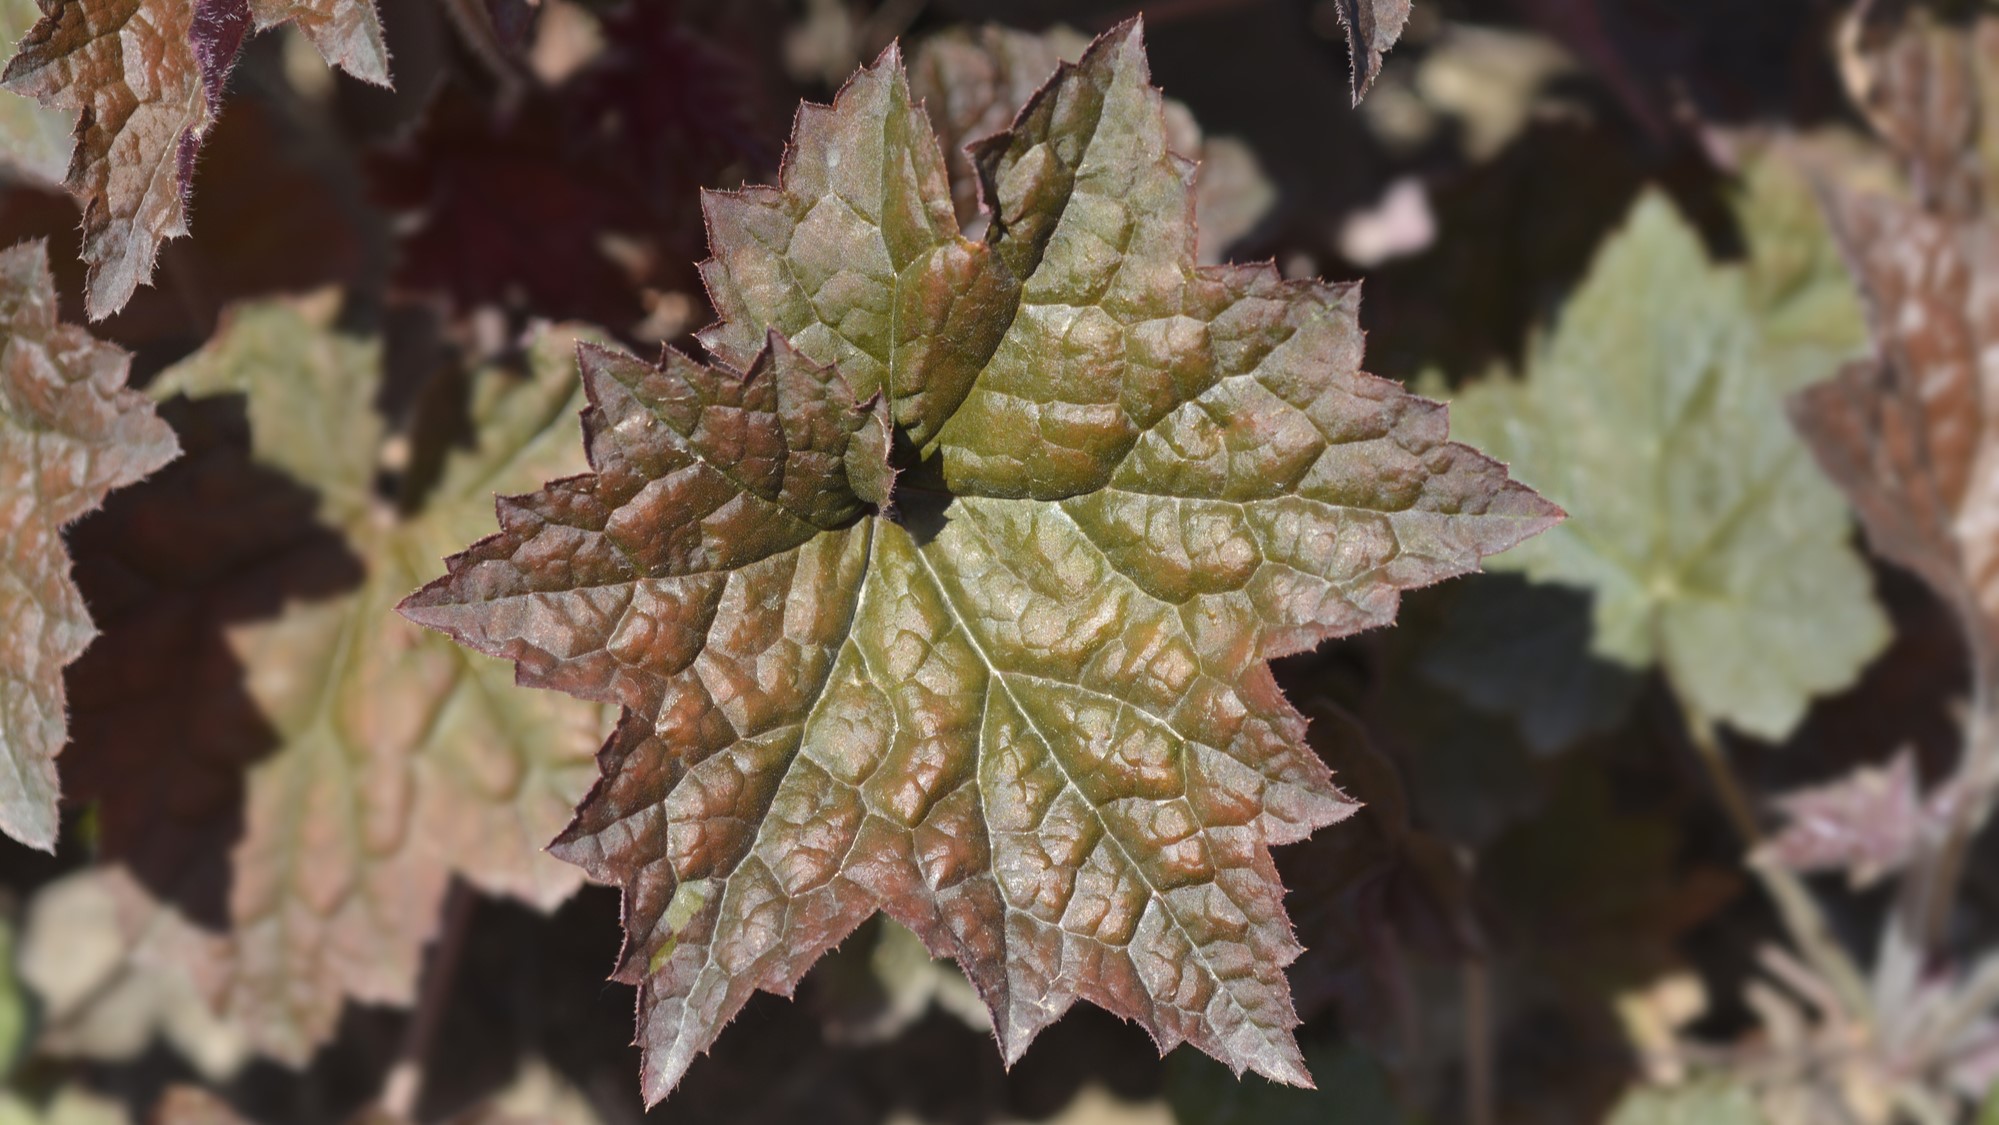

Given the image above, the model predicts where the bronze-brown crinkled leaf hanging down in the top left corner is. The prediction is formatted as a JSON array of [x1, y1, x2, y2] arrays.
[[0, 0, 388, 320]]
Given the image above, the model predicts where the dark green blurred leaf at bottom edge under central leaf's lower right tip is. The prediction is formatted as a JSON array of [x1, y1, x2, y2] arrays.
[[1165, 1043, 1413, 1125]]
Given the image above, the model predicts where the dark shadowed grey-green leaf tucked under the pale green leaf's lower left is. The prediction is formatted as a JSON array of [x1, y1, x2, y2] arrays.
[[1417, 573, 1641, 753]]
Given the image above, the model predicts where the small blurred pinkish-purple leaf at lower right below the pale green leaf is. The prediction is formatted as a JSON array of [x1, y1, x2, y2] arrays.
[[1765, 753, 1941, 889]]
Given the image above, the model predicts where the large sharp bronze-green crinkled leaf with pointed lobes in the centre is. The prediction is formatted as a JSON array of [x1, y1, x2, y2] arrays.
[[404, 22, 1559, 1101]]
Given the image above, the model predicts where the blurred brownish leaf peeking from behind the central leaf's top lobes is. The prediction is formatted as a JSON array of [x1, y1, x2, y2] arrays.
[[910, 24, 1277, 264]]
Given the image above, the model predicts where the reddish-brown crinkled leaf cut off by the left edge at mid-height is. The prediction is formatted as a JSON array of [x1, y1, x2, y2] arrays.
[[0, 242, 180, 851]]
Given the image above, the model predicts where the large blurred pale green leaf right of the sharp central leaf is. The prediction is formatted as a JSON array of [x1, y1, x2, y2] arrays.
[[1453, 186, 1887, 739]]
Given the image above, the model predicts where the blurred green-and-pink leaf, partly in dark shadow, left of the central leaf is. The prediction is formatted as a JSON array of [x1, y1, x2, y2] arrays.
[[66, 300, 610, 1063]]
